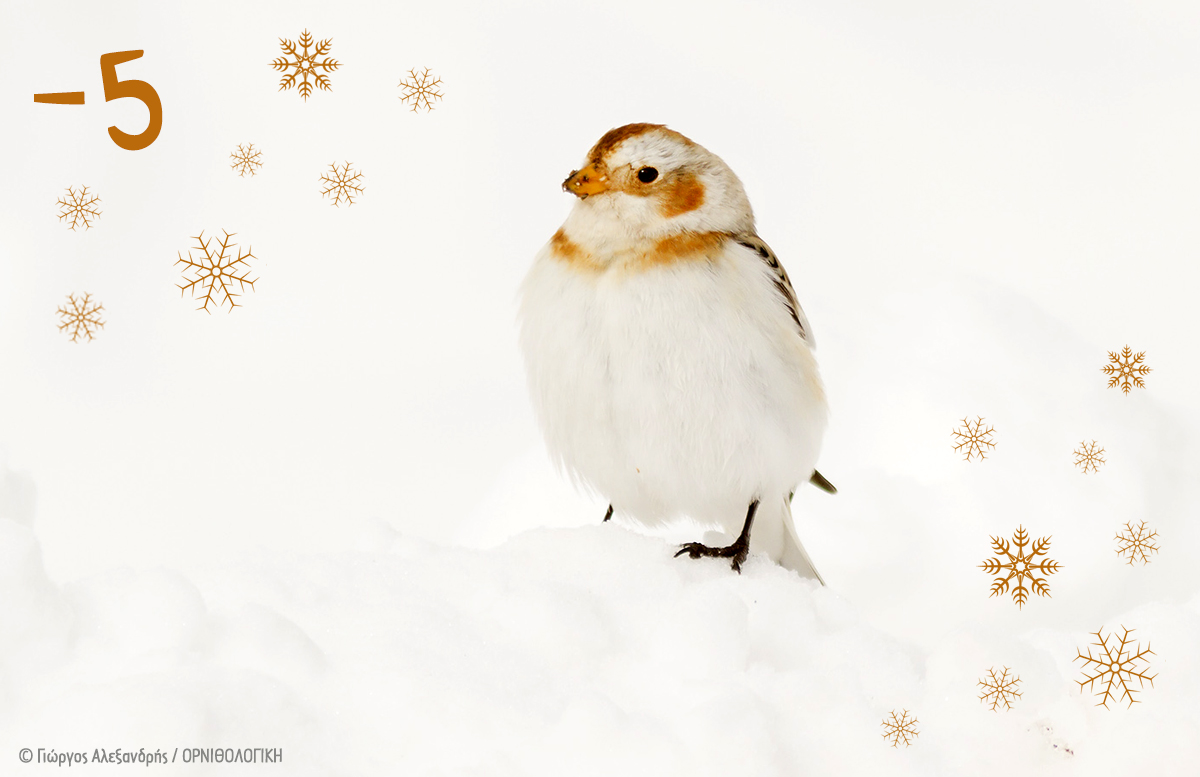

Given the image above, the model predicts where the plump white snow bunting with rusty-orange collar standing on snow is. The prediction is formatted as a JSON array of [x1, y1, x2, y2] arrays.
[[521, 124, 835, 582]]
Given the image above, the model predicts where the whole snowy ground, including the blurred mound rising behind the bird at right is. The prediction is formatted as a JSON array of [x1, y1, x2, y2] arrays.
[[0, 275, 1200, 775]]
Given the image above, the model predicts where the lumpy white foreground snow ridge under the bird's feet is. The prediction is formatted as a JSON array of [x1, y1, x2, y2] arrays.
[[0, 520, 1200, 776]]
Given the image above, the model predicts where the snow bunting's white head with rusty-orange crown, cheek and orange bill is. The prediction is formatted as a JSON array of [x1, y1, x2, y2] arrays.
[[563, 124, 754, 242]]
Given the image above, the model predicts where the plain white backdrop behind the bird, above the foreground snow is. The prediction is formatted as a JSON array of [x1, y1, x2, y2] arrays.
[[0, 0, 1200, 769]]
